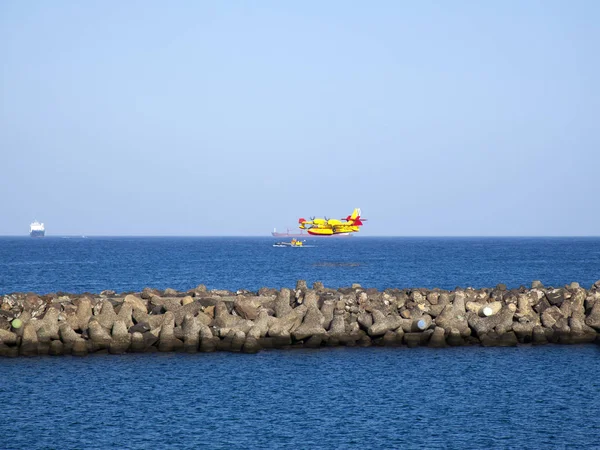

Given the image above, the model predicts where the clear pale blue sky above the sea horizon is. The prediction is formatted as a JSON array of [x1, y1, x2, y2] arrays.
[[0, 0, 600, 236]]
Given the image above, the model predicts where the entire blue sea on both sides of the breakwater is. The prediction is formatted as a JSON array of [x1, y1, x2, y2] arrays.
[[0, 236, 600, 449]]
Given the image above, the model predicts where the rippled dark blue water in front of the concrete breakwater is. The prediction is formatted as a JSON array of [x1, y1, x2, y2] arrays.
[[0, 345, 600, 449]]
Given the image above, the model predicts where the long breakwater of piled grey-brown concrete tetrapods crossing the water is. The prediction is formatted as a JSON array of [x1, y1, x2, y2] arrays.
[[0, 280, 600, 356]]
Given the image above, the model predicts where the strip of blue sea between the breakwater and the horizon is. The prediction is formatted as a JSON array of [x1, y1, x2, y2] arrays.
[[0, 237, 600, 294]]
